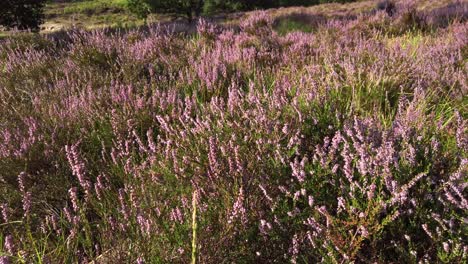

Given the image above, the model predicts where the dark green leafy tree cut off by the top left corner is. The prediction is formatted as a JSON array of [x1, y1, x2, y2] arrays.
[[0, 0, 46, 30]]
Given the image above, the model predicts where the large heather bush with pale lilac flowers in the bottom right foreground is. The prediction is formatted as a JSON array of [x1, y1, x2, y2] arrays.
[[263, 93, 463, 262]]
